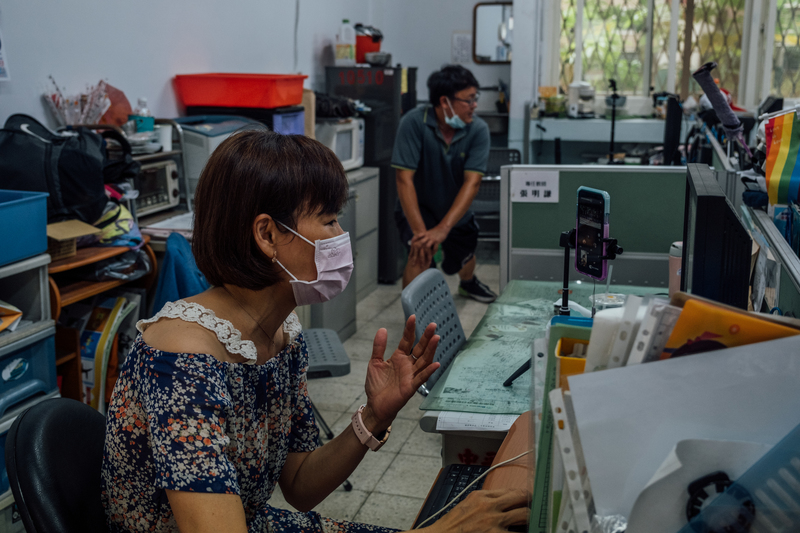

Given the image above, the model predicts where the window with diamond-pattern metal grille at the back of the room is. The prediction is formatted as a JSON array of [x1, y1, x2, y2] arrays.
[[559, 0, 748, 98]]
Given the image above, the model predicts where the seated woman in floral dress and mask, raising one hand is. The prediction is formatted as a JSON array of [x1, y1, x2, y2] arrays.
[[102, 130, 528, 533]]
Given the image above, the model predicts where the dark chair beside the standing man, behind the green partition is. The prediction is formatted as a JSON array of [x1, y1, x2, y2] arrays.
[[471, 148, 522, 241]]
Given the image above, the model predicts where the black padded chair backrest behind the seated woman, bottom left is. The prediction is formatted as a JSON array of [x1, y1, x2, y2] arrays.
[[5, 398, 109, 533]]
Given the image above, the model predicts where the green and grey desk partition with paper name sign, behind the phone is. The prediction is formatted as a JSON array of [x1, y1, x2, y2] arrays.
[[500, 165, 686, 292]]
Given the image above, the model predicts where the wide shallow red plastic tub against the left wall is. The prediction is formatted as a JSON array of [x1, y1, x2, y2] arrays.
[[175, 73, 308, 108]]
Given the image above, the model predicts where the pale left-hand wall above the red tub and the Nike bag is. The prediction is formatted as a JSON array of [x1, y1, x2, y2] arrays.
[[0, 0, 368, 124]]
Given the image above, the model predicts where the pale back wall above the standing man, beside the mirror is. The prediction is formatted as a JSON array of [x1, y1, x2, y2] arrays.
[[370, 0, 511, 107]]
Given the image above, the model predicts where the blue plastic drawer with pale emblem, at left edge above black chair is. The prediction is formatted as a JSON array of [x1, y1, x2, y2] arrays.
[[0, 327, 58, 417]]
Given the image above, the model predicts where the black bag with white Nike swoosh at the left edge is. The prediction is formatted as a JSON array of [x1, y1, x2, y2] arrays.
[[0, 114, 108, 224]]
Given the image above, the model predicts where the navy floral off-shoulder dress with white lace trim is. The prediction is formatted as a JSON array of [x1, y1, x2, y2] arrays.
[[102, 300, 395, 533]]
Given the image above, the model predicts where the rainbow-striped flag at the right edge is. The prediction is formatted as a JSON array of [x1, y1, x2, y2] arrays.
[[765, 113, 800, 205]]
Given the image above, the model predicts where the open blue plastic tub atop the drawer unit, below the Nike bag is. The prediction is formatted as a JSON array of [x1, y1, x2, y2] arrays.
[[0, 189, 49, 266]]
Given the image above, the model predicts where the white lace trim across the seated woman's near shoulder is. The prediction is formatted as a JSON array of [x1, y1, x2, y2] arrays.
[[136, 300, 256, 365]]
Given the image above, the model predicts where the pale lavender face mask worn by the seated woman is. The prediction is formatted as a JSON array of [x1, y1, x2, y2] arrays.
[[276, 222, 353, 305]]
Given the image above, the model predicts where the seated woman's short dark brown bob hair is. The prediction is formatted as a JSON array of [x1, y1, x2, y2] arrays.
[[192, 129, 347, 290]]
